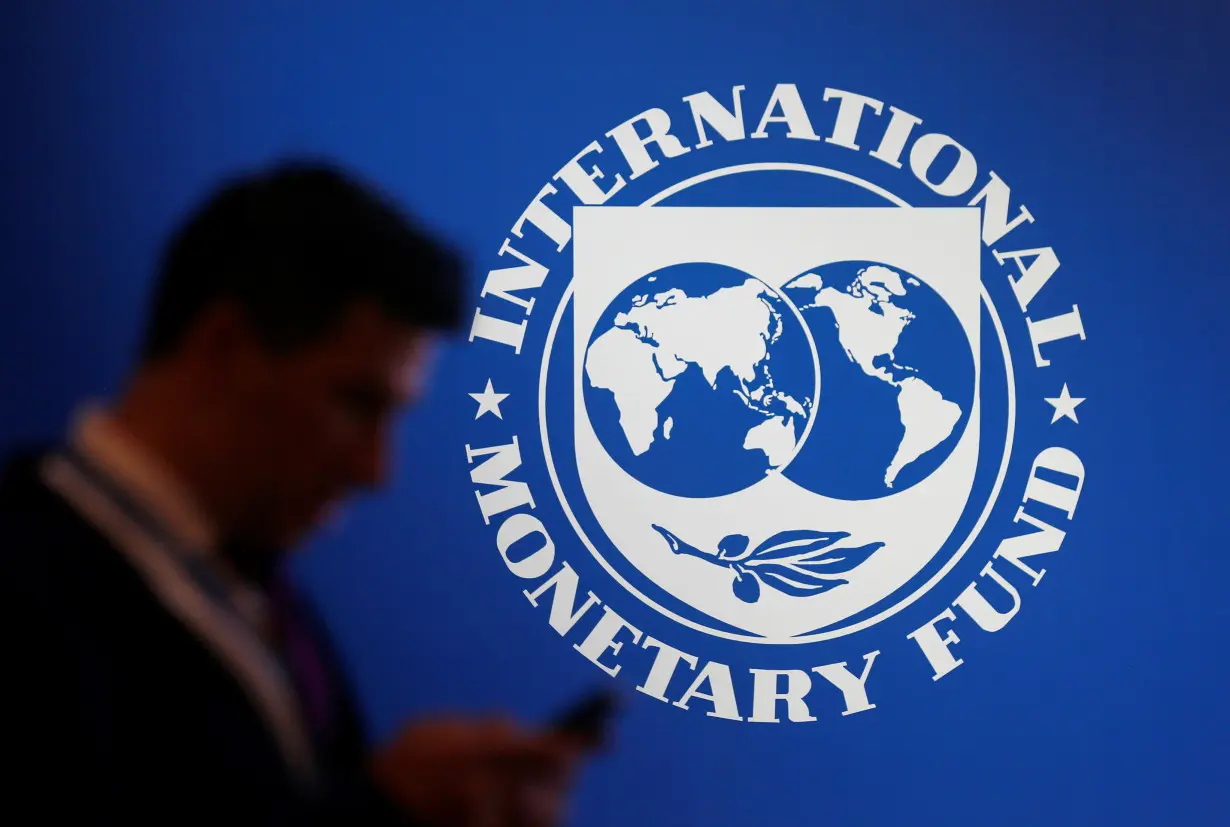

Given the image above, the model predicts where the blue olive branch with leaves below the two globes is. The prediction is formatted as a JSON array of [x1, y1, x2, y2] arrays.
[[653, 525, 884, 603]]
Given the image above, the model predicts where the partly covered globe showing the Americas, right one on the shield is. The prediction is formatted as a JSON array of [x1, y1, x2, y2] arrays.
[[782, 261, 975, 500]]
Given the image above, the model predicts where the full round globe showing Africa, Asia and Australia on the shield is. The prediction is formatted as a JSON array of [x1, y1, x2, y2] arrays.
[[583, 263, 819, 497]]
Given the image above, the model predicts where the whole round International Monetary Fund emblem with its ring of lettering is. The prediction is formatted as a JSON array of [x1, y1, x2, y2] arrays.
[[465, 84, 1085, 722]]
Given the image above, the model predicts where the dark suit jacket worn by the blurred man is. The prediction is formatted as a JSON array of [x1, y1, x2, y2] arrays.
[[0, 449, 408, 827]]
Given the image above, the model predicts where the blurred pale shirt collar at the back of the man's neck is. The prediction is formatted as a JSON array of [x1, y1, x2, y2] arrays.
[[69, 405, 218, 551]]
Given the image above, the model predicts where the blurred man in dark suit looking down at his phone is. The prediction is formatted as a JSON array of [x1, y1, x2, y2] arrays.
[[0, 164, 590, 827]]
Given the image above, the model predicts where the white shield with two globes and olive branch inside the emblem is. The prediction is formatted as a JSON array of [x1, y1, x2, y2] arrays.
[[553, 207, 982, 644]]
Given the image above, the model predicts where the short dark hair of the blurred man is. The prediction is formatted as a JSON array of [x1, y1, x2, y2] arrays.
[[140, 160, 464, 362]]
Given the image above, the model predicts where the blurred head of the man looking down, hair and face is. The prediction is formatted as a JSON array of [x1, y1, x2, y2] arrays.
[[135, 158, 462, 545]]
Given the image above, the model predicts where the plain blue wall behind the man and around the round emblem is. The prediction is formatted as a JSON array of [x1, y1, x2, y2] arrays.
[[0, 0, 1230, 827]]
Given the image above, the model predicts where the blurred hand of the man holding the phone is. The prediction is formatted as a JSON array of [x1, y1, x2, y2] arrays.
[[371, 719, 583, 827]]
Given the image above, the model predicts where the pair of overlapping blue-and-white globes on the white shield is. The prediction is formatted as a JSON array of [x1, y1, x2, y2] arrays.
[[583, 261, 974, 500]]
